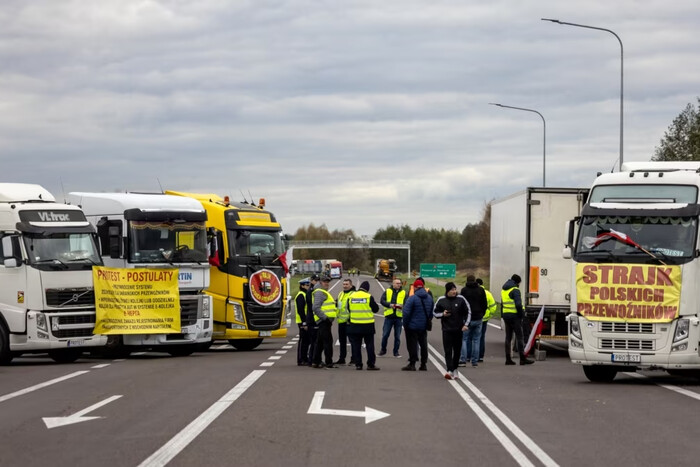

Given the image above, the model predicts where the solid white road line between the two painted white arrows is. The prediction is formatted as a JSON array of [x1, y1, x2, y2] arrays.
[[139, 370, 267, 467]]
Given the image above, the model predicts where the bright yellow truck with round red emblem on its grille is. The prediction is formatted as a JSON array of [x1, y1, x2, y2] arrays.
[[166, 191, 291, 350]]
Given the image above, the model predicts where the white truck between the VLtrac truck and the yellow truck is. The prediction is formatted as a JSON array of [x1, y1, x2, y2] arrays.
[[69, 192, 213, 356]]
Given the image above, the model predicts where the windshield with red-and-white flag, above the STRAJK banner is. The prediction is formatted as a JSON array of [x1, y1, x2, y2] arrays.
[[576, 216, 697, 262]]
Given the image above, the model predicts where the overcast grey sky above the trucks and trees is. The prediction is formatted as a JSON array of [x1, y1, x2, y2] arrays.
[[0, 0, 700, 235]]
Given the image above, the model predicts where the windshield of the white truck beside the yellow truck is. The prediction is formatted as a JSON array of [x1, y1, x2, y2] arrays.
[[129, 221, 207, 263]]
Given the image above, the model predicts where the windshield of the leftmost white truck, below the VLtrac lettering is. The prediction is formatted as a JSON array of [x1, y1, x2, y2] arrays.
[[24, 232, 102, 270]]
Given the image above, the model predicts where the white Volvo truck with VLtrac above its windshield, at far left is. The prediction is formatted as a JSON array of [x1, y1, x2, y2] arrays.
[[0, 183, 107, 364]]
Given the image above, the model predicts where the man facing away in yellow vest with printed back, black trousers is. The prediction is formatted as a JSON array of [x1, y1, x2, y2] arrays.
[[347, 281, 379, 370]]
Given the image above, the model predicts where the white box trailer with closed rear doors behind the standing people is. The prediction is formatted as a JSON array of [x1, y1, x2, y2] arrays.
[[490, 187, 589, 348]]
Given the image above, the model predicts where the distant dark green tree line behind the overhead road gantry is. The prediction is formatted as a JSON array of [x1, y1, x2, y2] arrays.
[[290, 203, 491, 272]]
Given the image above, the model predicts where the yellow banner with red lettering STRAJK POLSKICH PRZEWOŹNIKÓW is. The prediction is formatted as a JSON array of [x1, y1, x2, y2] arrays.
[[576, 263, 681, 323]]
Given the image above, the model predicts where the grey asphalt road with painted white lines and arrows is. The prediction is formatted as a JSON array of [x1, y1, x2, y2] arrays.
[[0, 278, 700, 466]]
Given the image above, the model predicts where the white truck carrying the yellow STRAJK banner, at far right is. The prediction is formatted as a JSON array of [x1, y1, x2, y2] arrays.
[[564, 162, 700, 382]]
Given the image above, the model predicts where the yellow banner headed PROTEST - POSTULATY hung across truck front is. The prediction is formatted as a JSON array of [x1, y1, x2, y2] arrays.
[[92, 266, 180, 334]]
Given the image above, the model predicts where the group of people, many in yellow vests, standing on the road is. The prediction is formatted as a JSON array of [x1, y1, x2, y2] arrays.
[[294, 274, 533, 379]]
